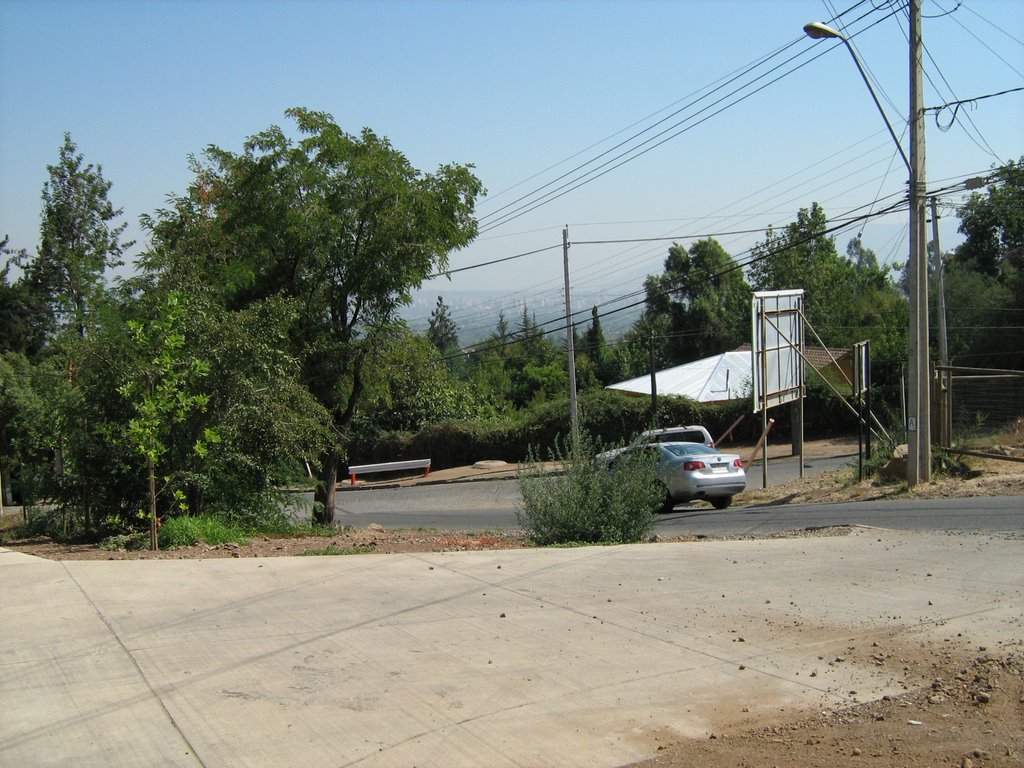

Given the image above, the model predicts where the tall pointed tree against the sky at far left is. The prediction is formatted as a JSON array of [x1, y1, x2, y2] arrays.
[[24, 133, 133, 337]]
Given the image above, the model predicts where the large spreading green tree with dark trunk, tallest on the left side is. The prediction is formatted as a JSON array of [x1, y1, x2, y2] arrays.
[[145, 109, 482, 523]]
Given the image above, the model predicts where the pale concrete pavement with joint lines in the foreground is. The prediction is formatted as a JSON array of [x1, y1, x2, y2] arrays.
[[0, 529, 1024, 768]]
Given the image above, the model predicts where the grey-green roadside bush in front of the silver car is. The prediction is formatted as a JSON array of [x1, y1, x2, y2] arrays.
[[516, 437, 665, 545]]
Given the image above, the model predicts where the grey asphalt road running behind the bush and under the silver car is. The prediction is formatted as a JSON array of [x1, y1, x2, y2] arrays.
[[327, 457, 1024, 537]]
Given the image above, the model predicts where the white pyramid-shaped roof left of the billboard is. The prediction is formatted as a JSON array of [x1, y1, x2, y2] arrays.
[[605, 351, 753, 402]]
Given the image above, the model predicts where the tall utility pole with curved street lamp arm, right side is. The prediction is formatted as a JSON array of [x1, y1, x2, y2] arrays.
[[804, 0, 932, 487]]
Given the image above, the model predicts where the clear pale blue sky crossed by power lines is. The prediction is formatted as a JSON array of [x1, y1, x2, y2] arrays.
[[0, 0, 1024, 335]]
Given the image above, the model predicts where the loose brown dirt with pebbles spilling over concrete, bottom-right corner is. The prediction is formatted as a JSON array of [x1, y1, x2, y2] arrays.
[[632, 647, 1024, 768]]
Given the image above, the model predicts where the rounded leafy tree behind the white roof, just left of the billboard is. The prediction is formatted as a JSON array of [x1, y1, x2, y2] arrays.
[[645, 238, 751, 364]]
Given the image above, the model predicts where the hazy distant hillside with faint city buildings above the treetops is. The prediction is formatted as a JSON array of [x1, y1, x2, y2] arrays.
[[401, 287, 643, 346]]
